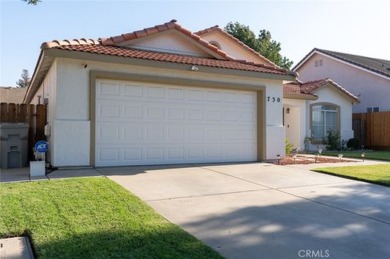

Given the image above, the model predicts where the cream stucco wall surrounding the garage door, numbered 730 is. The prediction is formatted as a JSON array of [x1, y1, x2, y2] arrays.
[[34, 58, 285, 167]]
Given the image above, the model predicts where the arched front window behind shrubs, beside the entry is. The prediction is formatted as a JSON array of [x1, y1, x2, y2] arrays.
[[311, 104, 340, 143]]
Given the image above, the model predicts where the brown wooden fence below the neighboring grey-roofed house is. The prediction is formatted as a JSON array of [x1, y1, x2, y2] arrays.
[[352, 111, 390, 150]]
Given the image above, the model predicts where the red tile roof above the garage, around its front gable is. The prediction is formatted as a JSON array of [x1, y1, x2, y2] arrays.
[[41, 20, 295, 76]]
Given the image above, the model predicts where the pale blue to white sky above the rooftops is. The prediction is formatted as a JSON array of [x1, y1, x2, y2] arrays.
[[0, 0, 390, 86]]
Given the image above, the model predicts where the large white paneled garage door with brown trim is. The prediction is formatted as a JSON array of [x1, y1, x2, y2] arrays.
[[95, 80, 257, 166]]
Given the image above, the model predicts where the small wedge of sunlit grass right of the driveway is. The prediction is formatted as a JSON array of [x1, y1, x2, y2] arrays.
[[313, 164, 390, 186]]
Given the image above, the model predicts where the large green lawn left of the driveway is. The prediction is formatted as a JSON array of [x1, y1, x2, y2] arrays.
[[0, 177, 221, 258]]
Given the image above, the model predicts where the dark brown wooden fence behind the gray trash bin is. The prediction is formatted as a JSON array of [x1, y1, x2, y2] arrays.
[[0, 103, 46, 159]]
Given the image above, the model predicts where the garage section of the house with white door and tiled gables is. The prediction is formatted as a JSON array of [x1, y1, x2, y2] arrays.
[[24, 20, 295, 167]]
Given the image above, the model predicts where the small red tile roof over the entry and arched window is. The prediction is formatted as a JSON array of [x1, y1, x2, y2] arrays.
[[283, 78, 359, 103]]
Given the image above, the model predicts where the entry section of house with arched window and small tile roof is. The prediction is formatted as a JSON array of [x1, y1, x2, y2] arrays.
[[283, 79, 359, 150]]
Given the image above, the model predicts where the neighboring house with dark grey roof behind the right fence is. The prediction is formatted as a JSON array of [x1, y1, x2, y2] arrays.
[[293, 48, 390, 113]]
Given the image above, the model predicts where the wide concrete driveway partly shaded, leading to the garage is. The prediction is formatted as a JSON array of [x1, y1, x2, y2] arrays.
[[98, 163, 390, 258]]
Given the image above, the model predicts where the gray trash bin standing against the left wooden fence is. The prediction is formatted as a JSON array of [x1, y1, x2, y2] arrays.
[[0, 123, 29, 169]]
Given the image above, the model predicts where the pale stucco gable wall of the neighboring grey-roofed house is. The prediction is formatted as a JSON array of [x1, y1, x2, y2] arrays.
[[297, 54, 390, 113]]
